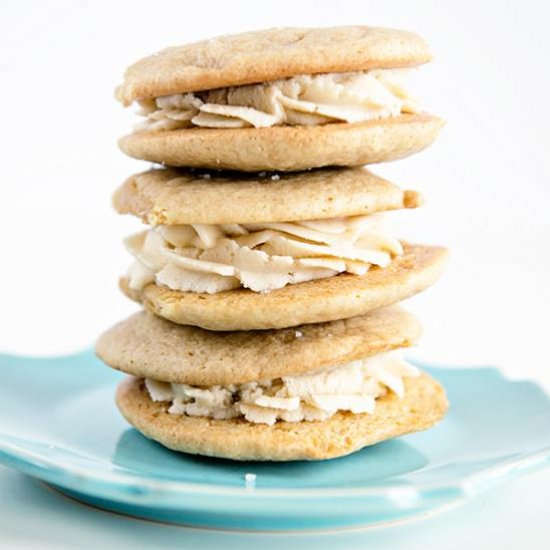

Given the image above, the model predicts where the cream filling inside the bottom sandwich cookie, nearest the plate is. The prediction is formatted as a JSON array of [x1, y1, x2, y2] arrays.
[[145, 350, 419, 426]]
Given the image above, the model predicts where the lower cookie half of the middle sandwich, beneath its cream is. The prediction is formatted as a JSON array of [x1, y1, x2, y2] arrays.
[[120, 244, 448, 331]]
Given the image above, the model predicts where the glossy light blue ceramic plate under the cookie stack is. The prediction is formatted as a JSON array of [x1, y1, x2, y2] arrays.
[[0, 351, 550, 530]]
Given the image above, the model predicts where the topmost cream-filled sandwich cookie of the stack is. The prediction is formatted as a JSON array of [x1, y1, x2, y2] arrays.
[[117, 26, 443, 171]]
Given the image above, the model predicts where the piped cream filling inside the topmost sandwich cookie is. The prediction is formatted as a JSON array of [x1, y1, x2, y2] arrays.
[[134, 69, 419, 131]]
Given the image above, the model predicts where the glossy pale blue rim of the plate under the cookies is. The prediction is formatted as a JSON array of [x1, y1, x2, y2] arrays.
[[0, 354, 550, 503]]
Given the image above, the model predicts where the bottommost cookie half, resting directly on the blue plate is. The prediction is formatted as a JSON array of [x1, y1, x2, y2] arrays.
[[116, 373, 448, 461]]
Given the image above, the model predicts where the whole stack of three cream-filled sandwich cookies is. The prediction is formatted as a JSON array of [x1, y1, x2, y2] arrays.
[[97, 26, 447, 461]]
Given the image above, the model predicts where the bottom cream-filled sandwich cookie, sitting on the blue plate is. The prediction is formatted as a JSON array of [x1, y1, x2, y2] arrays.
[[97, 306, 447, 461]]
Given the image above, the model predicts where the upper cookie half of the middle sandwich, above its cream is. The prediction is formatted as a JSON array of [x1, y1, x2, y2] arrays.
[[113, 168, 422, 225]]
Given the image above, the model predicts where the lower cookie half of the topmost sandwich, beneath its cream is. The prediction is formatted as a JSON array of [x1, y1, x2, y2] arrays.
[[119, 113, 444, 172]]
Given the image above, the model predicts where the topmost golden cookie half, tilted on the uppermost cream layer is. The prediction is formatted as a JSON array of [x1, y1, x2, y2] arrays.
[[117, 26, 431, 105]]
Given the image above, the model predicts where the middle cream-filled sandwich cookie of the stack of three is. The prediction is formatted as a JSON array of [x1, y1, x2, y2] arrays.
[[114, 168, 446, 331]]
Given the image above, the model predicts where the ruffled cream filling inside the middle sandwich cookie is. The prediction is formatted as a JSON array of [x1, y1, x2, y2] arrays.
[[125, 214, 403, 294]]
